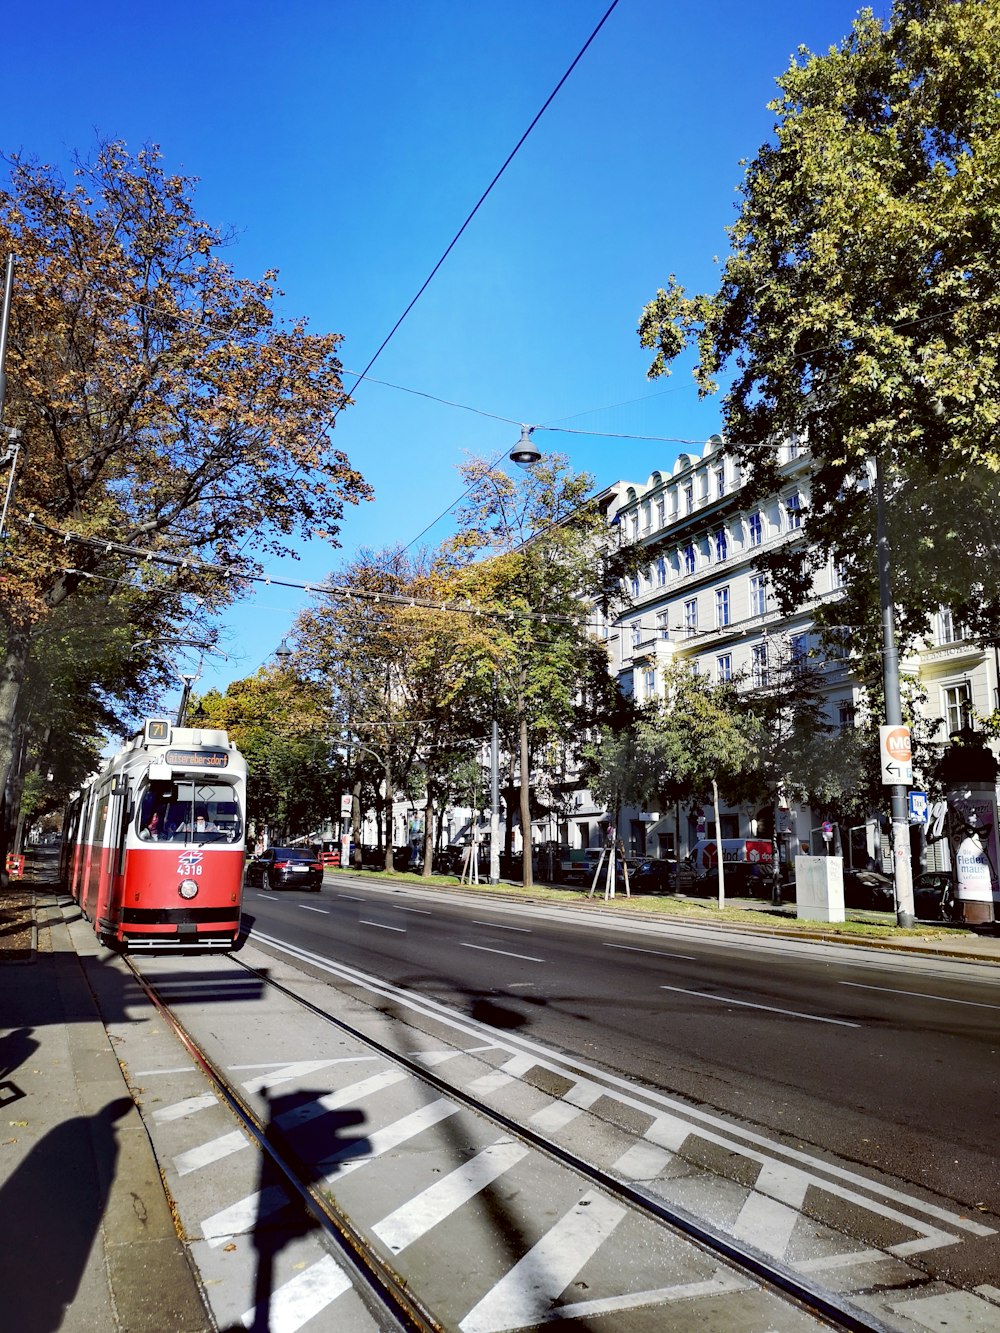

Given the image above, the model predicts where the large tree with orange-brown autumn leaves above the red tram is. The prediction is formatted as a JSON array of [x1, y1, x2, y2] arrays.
[[0, 143, 371, 853]]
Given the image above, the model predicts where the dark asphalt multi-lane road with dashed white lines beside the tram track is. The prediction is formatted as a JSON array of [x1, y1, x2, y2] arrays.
[[244, 874, 1000, 1226]]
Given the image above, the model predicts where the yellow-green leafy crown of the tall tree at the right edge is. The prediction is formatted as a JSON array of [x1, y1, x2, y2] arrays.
[[639, 0, 1000, 643]]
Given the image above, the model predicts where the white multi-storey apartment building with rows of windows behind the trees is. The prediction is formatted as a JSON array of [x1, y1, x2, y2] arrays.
[[565, 436, 1000, 874]]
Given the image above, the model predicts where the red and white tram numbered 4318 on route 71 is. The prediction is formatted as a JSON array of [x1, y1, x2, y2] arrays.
[[63, 718, 247, 949]]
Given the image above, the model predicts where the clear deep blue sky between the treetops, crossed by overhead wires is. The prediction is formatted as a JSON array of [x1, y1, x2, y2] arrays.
[[0, 0, 888, 706]]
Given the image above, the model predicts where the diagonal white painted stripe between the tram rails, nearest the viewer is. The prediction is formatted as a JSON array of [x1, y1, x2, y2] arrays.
[[459, 1189, 625, 1333]]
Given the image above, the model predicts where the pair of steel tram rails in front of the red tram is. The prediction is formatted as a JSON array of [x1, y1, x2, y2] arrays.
[[124, 954, 892, 1333]]
